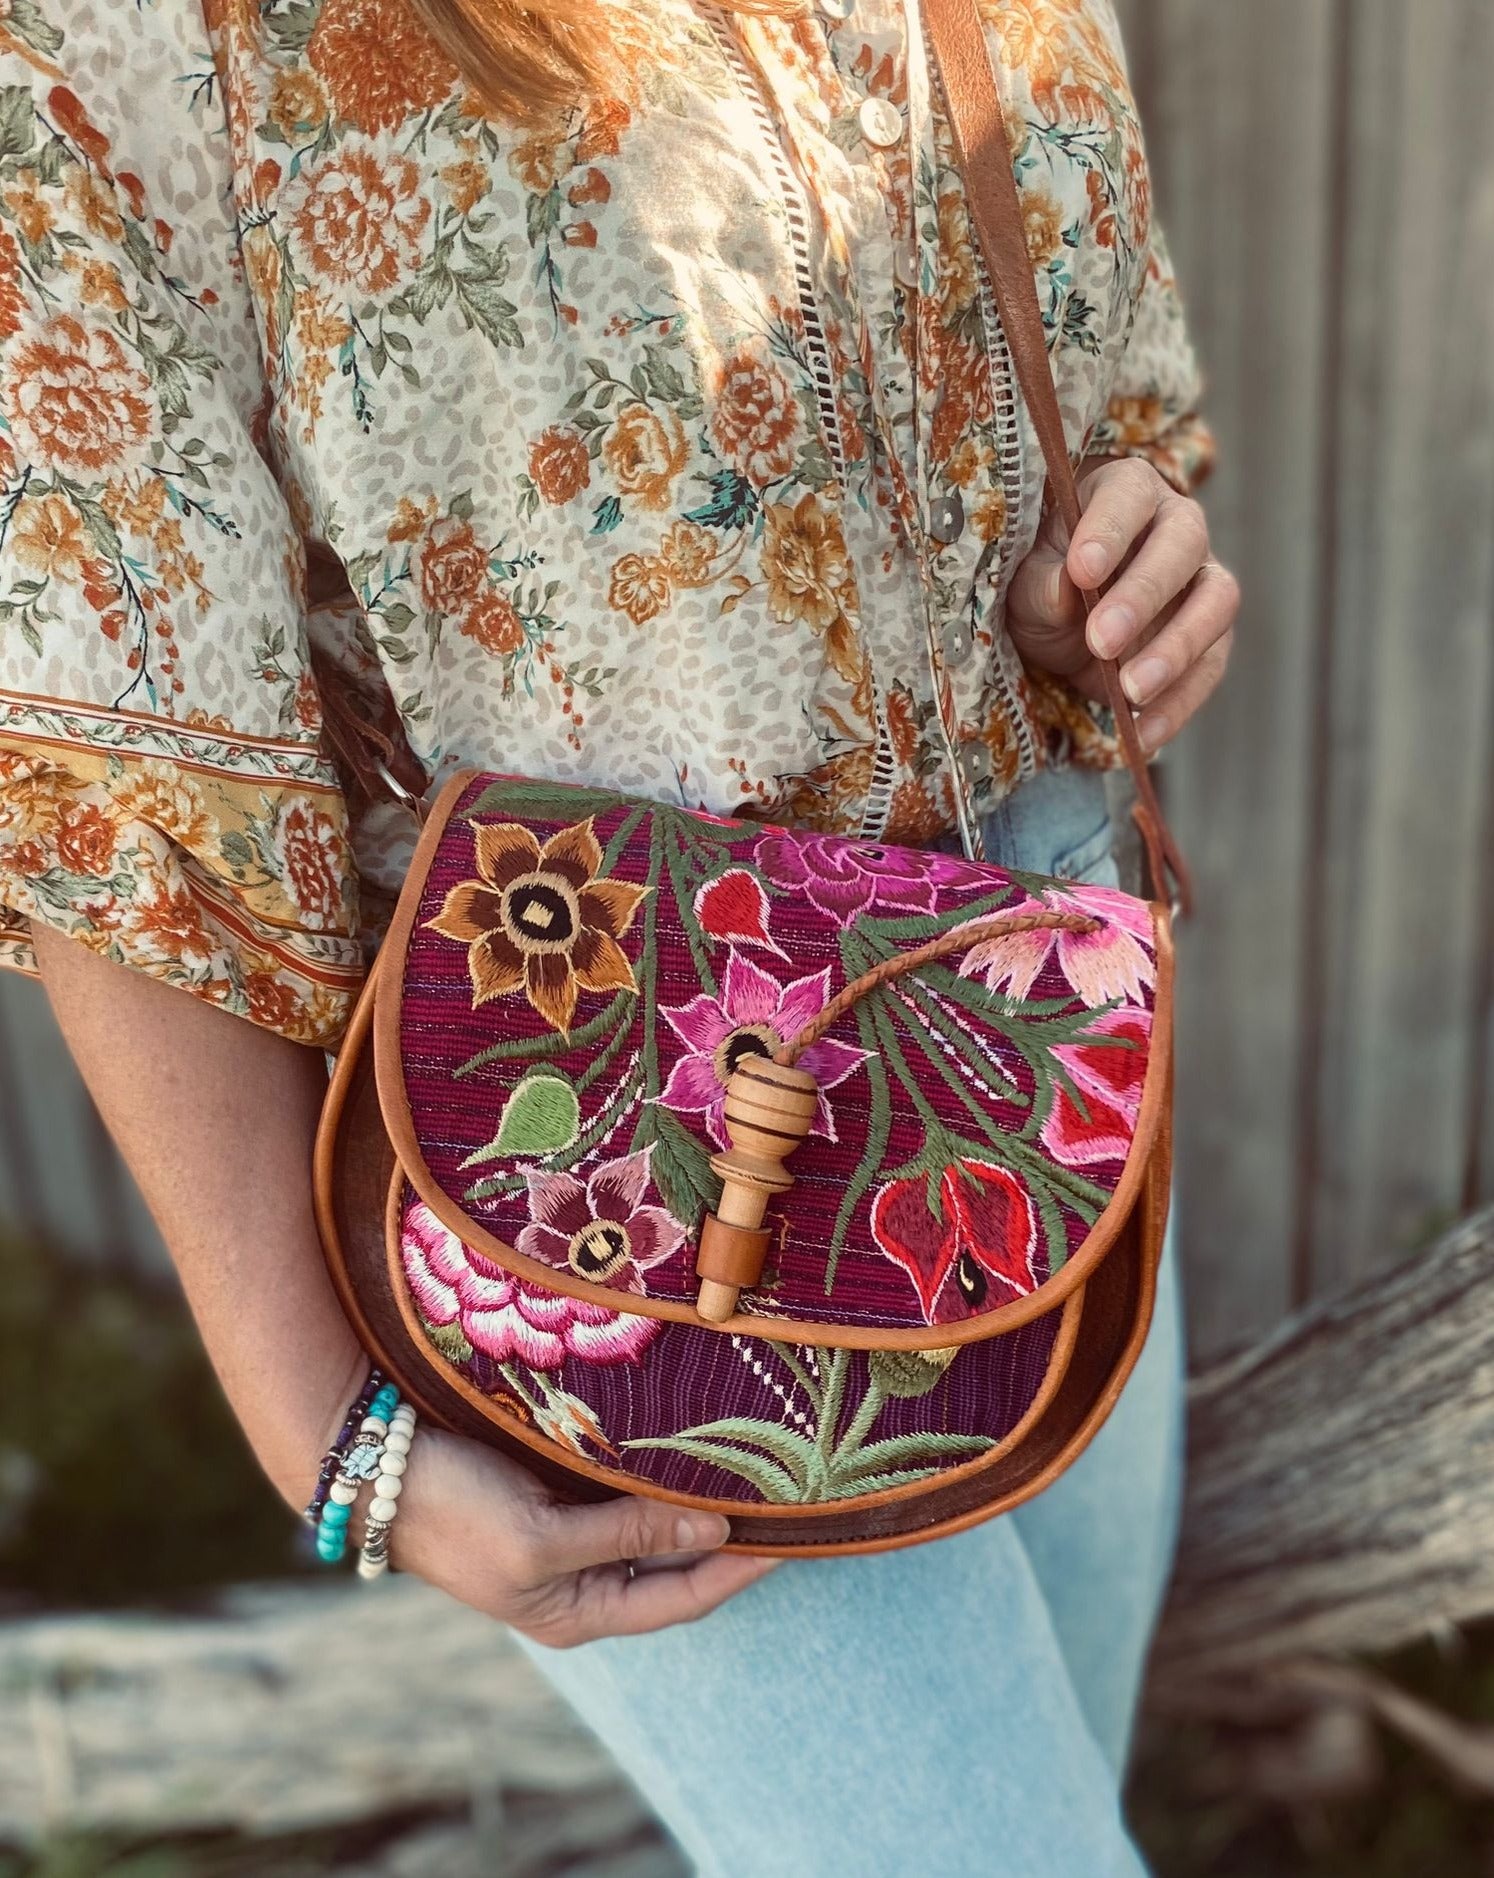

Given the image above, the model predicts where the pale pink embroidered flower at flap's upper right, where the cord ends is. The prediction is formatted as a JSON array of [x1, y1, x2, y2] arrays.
[[959, 886, 1156, 1010]]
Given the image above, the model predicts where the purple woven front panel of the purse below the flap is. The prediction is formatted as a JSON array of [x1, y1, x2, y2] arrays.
[[390, 1189, 1060, 1504]]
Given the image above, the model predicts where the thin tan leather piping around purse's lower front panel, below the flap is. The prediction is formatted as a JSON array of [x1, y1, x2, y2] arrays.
[[383, 1141, 1083, 1521]]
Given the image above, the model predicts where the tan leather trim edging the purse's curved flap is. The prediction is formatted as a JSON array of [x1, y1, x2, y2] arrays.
[[374, 770, 1173, 1350]]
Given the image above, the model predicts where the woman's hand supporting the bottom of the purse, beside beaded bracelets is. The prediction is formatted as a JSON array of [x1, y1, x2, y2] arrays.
[[389, 1429, 775, 1649]]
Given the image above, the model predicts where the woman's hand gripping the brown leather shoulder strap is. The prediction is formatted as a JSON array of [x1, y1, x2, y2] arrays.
[[1006, 458, 1241, 751]]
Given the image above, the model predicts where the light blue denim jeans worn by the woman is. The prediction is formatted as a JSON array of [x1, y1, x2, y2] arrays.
[[520, 772, 1182, 1878]]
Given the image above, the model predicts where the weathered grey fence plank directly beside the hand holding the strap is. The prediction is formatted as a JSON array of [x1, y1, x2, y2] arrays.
[[1121, 0, 1336, 1352]]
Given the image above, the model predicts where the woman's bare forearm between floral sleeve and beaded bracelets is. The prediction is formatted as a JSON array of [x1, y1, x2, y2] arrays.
[[36, 930, 366, 1504]]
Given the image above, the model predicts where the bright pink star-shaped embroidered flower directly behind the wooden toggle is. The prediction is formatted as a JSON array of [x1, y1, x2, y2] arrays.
[[659, 952, 867, 1147]]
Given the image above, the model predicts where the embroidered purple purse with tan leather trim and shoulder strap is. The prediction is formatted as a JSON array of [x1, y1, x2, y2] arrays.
[[317, 0, 1186, 1553]]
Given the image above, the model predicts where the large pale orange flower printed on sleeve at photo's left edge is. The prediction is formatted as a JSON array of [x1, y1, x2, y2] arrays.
[[0, 314, 156, 477]]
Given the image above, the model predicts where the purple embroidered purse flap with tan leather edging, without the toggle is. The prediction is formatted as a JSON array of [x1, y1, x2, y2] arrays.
[[377, 776, 1171, 1347]]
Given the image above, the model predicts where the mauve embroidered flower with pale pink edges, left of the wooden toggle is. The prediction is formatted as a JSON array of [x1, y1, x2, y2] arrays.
[[514, 1147, 685, 1292]]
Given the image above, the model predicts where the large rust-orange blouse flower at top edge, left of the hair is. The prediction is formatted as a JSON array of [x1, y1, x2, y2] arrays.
[[306, 0, 458, 135]]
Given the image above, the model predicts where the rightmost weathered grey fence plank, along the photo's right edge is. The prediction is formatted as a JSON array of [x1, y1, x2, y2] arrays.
[[1308, 0, 1494, 1288]]
